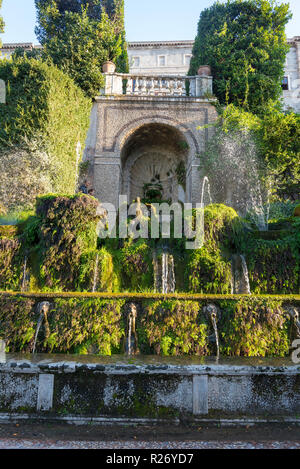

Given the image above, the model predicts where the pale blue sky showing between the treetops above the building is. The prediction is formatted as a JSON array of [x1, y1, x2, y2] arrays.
[[1, 0, 300, 43]]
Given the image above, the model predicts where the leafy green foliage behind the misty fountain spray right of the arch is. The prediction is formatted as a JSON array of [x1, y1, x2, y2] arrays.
[[201, 104, 300, 202]]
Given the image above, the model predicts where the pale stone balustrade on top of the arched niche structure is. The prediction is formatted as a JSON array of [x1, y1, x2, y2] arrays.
[[101, 73, 212, 98]]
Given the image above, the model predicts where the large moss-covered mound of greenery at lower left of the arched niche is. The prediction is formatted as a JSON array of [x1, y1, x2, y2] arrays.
[[36, 194, 99, 291]]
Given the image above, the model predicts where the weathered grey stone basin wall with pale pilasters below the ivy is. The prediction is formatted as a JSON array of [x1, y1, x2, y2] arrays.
[[0, 358, 300, 424]]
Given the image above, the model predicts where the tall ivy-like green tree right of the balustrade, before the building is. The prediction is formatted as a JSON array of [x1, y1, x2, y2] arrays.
[[189, 0, 291, 113]]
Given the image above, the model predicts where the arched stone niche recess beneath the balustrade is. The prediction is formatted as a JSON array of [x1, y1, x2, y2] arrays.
[[120, 121, 192, 202]]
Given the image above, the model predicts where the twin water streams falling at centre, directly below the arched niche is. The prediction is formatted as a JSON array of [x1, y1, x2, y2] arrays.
[[153, 250, 176, 293]]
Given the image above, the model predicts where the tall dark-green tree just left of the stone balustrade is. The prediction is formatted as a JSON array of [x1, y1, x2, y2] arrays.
[[35, 0, 128, 98]]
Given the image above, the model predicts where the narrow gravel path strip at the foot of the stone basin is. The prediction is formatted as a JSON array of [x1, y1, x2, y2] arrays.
[[0, 439, 300, 450]]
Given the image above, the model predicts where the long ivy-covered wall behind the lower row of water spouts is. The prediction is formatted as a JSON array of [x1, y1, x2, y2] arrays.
[[0, 294, 300, 357]]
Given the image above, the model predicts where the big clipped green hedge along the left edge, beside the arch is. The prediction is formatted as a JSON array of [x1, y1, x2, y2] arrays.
[[0, 57, 91, 210]]
